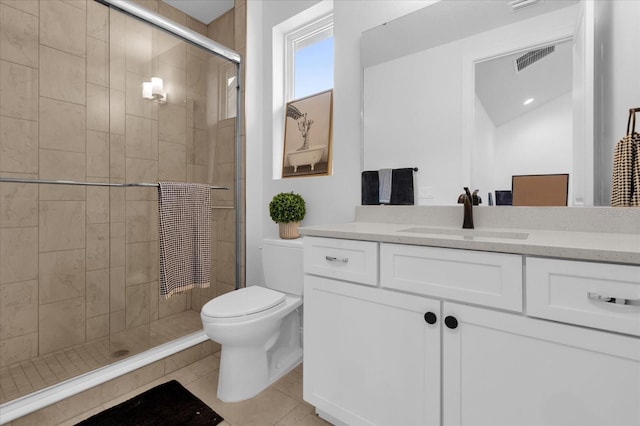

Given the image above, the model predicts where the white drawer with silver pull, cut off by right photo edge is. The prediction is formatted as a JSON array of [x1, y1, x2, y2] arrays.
[[526, 257, 640, 336]]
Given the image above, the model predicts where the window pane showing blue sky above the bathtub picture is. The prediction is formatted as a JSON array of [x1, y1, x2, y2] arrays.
[[285, 15, 333, 102]]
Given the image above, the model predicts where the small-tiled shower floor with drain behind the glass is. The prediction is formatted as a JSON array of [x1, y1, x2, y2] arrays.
[[0, 311, 202, 404]]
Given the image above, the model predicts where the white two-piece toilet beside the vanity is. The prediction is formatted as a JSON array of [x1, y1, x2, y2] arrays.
[[200, 238, 303, 402]]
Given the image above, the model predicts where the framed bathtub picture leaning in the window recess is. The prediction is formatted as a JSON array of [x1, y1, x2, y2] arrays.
[[282, 90, 333, 178]]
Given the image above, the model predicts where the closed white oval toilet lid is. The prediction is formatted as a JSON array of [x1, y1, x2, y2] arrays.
[[202, 286, 284, 318]]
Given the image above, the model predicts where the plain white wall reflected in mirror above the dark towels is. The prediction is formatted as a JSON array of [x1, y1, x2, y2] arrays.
[[364, 39, 469, 205]]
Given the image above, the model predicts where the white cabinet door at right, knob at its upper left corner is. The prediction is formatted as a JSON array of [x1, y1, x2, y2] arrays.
[[442, 303, 640, 426]]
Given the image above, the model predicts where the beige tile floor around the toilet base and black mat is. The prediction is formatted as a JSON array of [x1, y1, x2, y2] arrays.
[[62, 353, 330, 426]]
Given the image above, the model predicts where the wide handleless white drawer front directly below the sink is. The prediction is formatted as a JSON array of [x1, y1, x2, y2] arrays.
[[380, 244, 522, 312]]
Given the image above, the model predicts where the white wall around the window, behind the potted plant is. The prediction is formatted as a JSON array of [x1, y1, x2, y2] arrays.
[[245, 0, 424, 284]]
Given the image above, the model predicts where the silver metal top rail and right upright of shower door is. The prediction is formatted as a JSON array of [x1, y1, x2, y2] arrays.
[[94, 0, 244, 289]]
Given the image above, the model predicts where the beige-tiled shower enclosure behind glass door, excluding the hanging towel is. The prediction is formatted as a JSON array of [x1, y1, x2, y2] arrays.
[[0, 0, 242, 412]]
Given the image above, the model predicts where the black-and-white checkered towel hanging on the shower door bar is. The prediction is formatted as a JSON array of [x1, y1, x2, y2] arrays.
[[158, 182, 211, 298]]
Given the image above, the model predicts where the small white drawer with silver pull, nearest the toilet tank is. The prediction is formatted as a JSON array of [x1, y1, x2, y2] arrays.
[[304, 237, 378, 286]]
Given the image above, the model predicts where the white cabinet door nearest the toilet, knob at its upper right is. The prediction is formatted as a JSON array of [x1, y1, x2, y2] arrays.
[[304, 275, 440, 426]]
